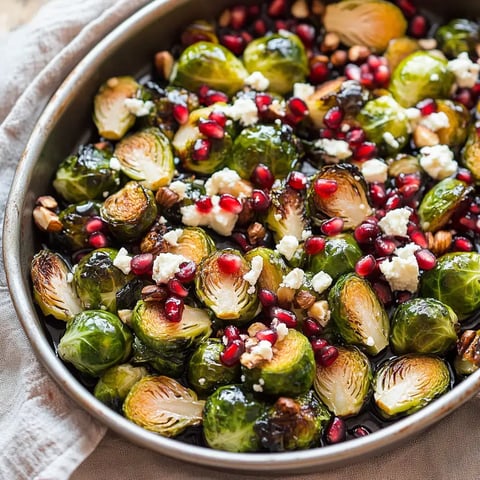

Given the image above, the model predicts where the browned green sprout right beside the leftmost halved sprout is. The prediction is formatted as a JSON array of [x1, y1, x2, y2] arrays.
[[73, 248, 130, 312]]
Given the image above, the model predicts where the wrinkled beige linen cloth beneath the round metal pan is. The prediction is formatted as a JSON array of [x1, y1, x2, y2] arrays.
[[0, 0, 480, 480]]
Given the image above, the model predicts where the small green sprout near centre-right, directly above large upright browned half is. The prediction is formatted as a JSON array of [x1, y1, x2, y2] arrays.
[[309, 233, 362, 280]]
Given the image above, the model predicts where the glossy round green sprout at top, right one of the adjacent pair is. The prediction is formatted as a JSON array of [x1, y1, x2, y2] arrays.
[[243, 31, 308, 95]]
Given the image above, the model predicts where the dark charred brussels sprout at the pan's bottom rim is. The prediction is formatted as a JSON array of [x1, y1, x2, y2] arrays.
[[255, 390, 331, 452]]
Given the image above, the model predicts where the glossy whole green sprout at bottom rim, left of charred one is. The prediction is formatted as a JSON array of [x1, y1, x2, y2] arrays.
[[203, 385, 265, 452]]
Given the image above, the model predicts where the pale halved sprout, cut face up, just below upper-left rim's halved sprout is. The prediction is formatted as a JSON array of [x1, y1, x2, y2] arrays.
[[114, 127, 175, 190]]
